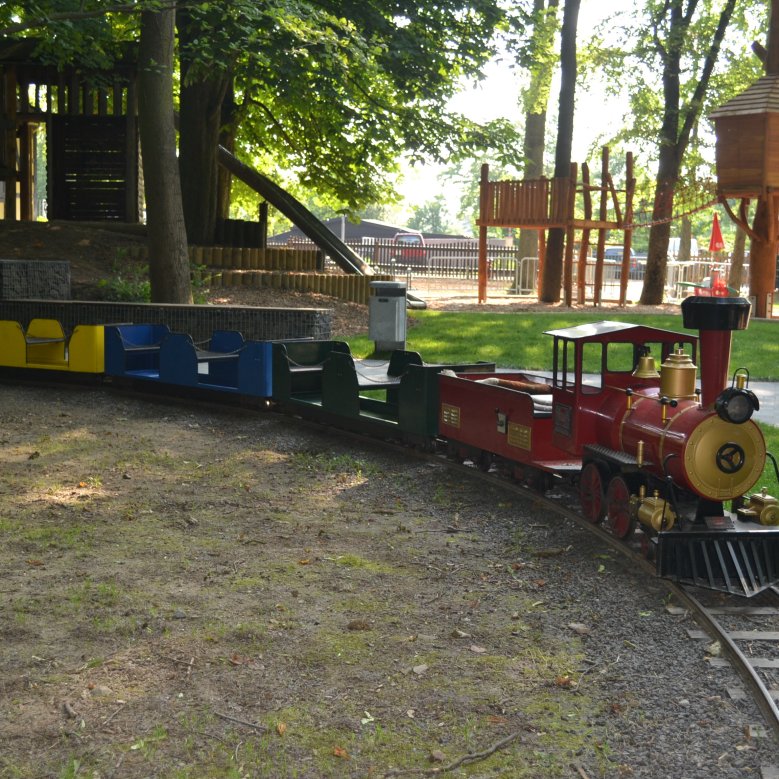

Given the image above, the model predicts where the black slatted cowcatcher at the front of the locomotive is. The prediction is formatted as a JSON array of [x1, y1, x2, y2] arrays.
[[656, 521, 779, 598]]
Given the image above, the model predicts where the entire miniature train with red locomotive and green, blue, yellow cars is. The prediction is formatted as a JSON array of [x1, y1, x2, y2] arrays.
[[0, 297, 779, 596]]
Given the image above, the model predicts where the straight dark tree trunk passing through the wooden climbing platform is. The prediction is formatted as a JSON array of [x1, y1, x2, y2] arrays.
[[539, 0, 581, 303]]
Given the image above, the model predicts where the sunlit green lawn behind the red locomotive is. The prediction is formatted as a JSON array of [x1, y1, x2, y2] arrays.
[[350, 311, 779, 495]]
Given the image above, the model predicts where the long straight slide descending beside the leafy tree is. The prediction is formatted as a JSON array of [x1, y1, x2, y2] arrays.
[[218, 146, 426, 308]]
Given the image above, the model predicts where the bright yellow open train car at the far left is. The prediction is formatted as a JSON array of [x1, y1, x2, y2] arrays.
[[0, 319, 105, 373]]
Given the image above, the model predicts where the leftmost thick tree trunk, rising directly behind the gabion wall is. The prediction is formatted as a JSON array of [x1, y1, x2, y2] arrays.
[[138, 10, 192, 303]]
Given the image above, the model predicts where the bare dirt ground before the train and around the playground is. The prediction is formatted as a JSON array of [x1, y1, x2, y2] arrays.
[[0, 219, 696, 779]]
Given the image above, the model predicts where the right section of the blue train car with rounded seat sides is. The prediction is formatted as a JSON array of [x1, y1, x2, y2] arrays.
[[160, 330, 273, 398]]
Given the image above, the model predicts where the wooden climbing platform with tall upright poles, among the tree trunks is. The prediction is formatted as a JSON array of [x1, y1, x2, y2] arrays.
[[477, 147, 635, 306]]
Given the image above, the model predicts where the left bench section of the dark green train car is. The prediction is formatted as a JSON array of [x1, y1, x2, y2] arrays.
[[273, 339, 350, 403]]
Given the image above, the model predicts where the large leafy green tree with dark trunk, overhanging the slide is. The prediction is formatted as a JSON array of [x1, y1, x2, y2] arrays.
[[179, 0, 516, 241]]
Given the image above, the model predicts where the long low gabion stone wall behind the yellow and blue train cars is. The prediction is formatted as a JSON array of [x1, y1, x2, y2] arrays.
[[0, 300, 333, 342]]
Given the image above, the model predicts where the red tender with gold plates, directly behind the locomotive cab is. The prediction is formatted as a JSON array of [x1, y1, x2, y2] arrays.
[[439, 372, 570, 472]]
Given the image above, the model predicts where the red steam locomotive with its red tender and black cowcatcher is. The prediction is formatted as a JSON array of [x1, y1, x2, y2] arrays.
[[439, 297, 779, 595]]
